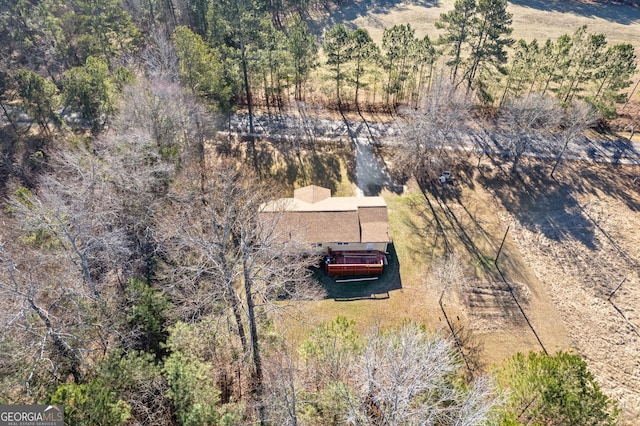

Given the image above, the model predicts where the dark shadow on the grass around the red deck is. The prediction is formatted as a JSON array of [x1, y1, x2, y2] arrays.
[[313, 244, 402, 302]]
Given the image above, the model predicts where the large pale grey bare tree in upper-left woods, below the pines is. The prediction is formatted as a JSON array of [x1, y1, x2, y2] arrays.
[[106, 79, 213, 280]]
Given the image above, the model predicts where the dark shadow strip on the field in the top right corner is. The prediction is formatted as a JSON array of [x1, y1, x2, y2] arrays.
[[511, 0, 640, 25]]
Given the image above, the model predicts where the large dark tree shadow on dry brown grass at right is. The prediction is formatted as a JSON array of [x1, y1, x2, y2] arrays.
[[479, 165, 597, 250]]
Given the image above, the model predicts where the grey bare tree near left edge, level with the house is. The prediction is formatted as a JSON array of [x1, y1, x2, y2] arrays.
[[9, 148, 130, 297]]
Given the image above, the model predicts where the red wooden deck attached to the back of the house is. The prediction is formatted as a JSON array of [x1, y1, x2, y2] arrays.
[[325, 250, 385, 277]]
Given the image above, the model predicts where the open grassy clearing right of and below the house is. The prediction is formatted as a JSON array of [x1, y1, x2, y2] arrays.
[[266, 139, 640, 419]]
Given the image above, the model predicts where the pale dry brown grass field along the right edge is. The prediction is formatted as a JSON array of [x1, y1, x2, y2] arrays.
[[493, 158, 640, 424]]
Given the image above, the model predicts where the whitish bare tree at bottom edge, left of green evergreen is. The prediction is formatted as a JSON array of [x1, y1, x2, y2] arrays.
[[346, 323, 498, 425]]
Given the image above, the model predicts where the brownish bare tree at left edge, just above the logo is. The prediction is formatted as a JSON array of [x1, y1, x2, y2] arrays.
[[0, 233, 97, 400]]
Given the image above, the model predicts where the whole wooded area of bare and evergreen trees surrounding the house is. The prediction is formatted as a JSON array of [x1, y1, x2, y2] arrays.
[[0, 0, 637, 425]]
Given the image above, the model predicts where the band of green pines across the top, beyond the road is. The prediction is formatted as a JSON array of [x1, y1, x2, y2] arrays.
[[0, 0, 637, 132]]
